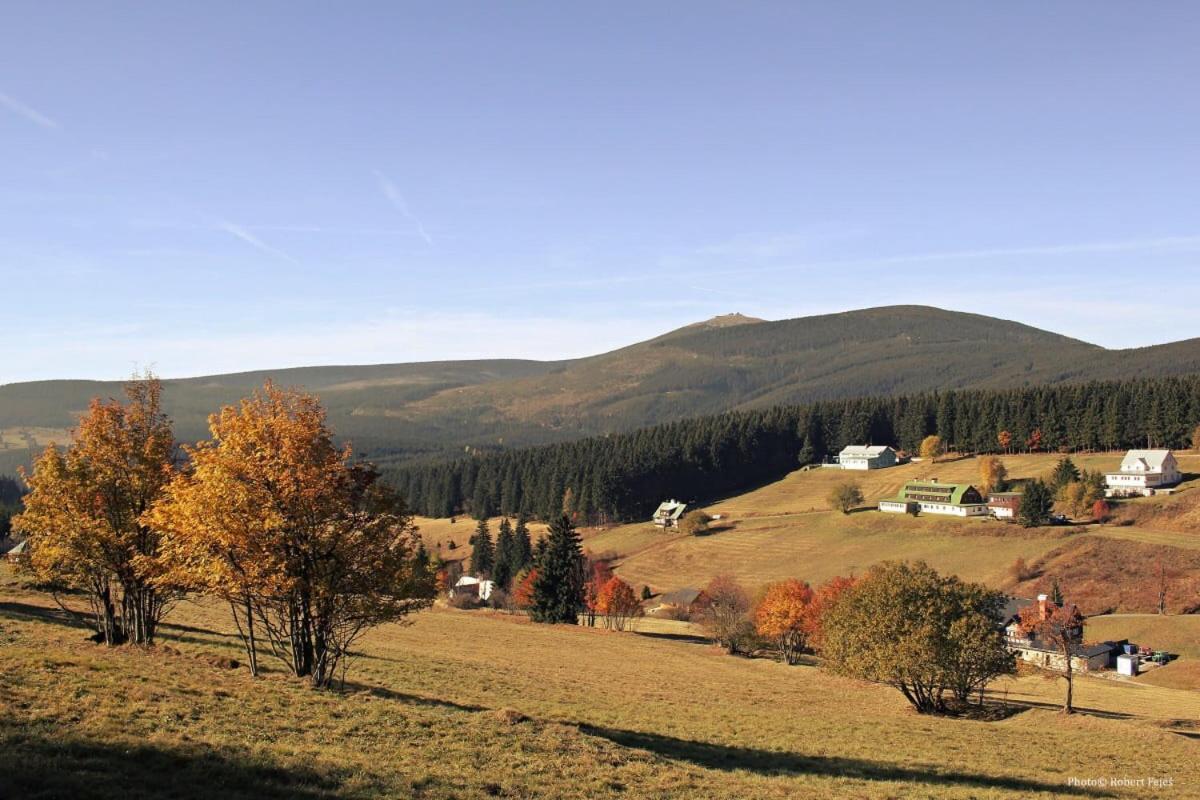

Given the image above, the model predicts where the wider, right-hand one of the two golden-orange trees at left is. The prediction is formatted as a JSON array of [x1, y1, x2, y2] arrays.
[[146, 383, 434, 687]]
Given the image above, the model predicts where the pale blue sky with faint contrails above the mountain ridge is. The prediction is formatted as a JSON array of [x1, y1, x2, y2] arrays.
[[0, 0, 1200, 383]]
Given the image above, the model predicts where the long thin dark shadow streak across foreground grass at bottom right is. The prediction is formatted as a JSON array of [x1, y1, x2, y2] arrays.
[[580, 724, 1114, 798]]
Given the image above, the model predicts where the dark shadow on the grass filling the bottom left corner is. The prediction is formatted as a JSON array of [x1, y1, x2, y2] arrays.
[[0, 718, 352, 800]]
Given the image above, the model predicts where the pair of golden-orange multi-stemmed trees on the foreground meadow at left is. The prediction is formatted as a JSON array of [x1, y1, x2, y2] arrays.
[[14, 375, 434, 686]]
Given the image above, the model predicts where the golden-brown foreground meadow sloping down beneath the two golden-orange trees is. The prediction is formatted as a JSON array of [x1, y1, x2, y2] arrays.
[[0, 563, 1200, 800]]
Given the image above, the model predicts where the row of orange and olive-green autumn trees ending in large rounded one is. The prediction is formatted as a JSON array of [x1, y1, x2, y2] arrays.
[[698, 563, 1015, 714]]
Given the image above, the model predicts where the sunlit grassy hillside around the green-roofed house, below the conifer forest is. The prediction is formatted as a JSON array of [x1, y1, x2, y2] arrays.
[[584, 453, 1200, 610]]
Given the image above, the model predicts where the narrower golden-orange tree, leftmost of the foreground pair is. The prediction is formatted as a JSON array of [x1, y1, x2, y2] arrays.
[[13, 374, 176, 645]]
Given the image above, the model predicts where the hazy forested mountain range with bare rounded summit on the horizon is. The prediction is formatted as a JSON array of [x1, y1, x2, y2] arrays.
[[7, 306, 1200, 473]]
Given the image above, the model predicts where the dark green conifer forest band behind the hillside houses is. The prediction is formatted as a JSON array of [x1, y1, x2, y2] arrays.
[[388, 375, 1200, 523]]
